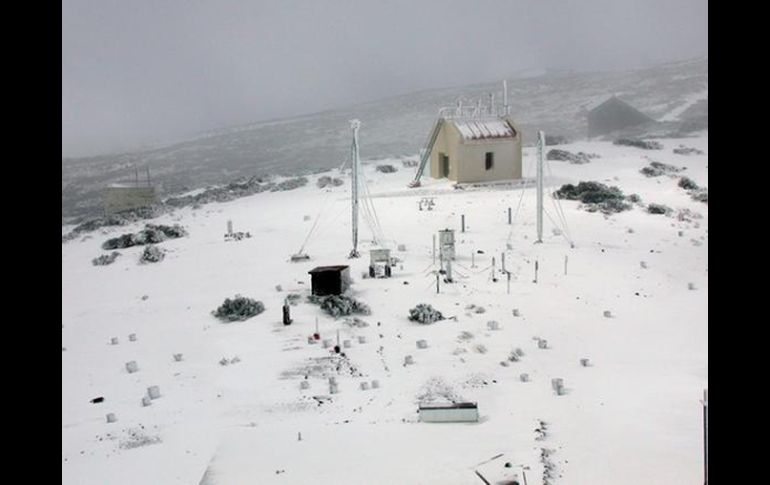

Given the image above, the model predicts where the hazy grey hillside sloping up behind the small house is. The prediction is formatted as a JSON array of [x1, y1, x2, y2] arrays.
[[62, 58, 708, 218]]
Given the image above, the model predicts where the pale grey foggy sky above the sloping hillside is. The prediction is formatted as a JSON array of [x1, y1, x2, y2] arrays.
[[62, 0, 708, 156]]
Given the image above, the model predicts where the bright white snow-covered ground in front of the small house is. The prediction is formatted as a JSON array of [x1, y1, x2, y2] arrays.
[[62, 134, 708, 485]]
